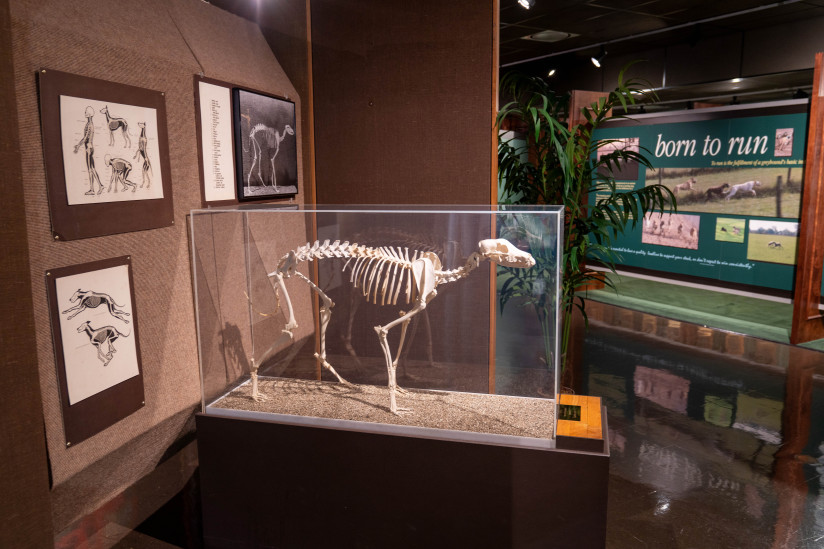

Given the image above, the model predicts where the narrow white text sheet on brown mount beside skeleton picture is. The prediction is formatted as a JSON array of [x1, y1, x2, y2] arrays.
[[194, 75, 237, 207]]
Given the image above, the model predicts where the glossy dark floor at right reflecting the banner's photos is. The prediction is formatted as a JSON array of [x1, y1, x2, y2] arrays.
[[581, 324, 824, 548]]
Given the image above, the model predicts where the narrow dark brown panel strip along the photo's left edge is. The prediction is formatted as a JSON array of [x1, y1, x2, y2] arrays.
[[0, 0, 52, 547]]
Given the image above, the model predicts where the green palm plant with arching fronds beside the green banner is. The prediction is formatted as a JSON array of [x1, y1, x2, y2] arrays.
[[496, 68, 675, 388]]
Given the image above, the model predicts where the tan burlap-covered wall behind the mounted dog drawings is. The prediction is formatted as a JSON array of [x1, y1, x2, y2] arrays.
[[10, 0, 304, 530]]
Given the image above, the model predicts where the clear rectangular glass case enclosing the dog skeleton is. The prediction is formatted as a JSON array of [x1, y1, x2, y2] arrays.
[[190, 205, 563, 448]]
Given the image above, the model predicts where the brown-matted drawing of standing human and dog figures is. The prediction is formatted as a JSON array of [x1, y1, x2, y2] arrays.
[[38, 69, 174, 240]]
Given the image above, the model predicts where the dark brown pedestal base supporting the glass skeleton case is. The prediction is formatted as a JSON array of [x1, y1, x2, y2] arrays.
[[197, 402, 609, 549]]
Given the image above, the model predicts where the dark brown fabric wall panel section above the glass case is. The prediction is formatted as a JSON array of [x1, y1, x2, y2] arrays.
[[311, 0, 497, 204]]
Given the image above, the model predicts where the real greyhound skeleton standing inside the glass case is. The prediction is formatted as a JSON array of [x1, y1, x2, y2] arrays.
[[252, 239, 535, 414]]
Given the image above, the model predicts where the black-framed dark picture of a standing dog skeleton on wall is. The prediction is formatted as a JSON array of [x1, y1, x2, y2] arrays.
[[232, 88, 298, 200]]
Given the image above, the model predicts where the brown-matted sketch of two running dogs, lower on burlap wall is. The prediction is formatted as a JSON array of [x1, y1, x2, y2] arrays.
[[46, 256, 144, 446]]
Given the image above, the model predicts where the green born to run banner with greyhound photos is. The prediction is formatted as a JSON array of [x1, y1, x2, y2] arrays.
[[590, 100, 808, 290]]
